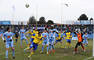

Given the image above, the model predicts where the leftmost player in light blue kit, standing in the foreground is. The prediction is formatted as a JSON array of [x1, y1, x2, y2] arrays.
[[3, 27, 15, 60]]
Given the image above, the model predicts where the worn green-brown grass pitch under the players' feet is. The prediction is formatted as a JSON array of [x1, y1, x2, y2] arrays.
[[0, 39, 94, 60]]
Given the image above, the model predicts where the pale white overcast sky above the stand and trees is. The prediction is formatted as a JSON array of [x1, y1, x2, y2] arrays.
[[0, 0, 94, 23]]
